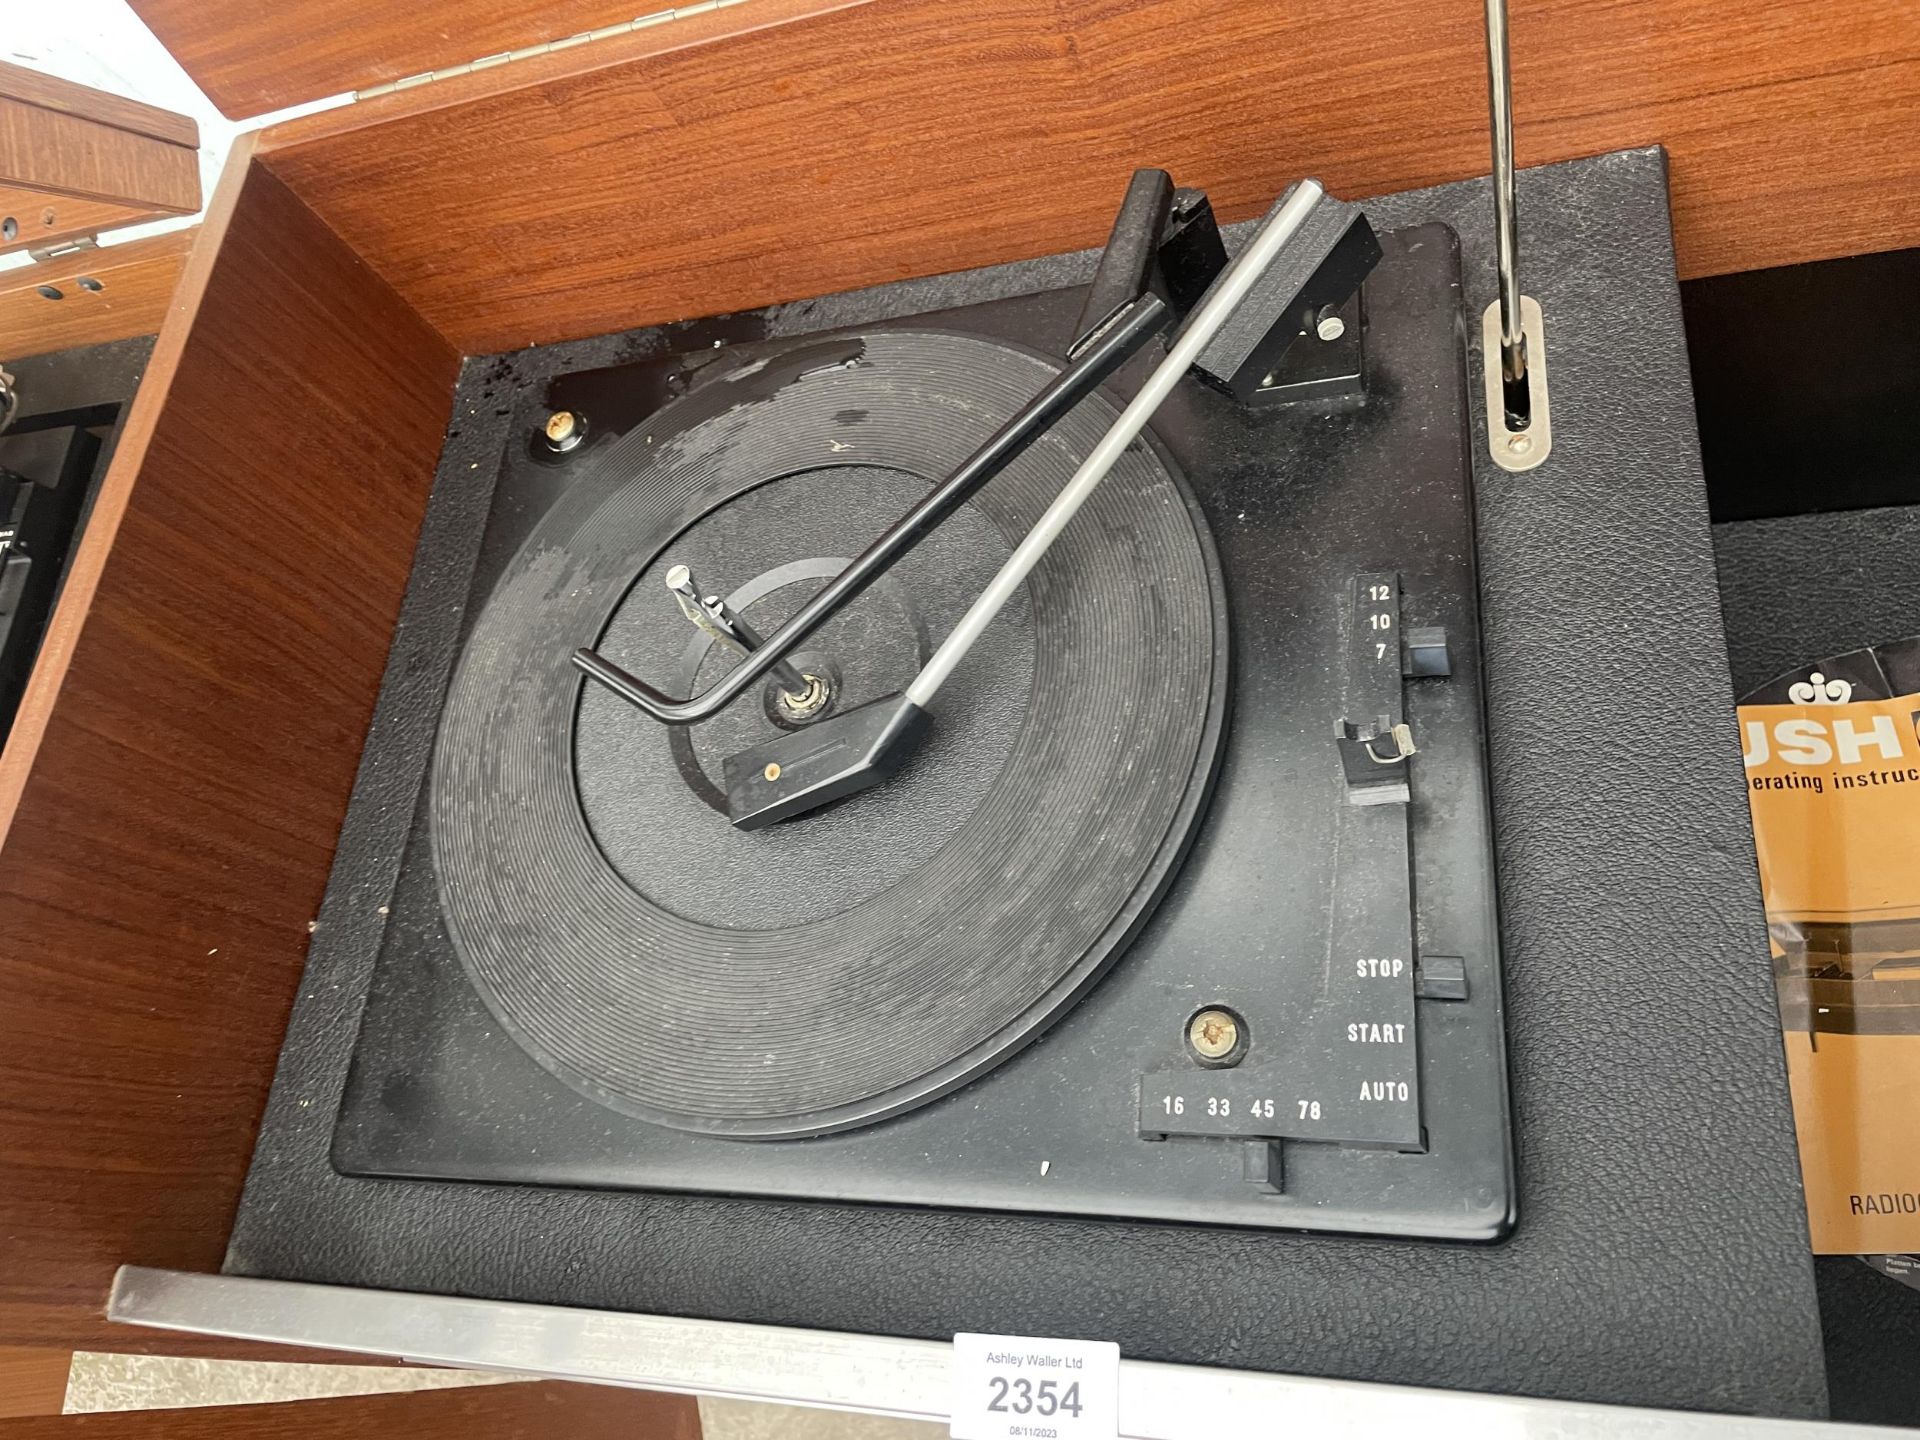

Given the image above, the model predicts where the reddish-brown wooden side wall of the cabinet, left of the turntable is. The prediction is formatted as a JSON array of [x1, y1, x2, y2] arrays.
[[0, 140, 459, 1352]]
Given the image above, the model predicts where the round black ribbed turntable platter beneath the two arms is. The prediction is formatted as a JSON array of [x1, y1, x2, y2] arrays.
[[432, 330, 1227, 1137]]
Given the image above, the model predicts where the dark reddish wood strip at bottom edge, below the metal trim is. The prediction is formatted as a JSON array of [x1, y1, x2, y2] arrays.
[[0, 1380, 701, 1440]]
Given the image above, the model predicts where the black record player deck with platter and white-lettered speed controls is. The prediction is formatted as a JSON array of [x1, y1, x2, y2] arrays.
[[334, 173, 1513, 1240]]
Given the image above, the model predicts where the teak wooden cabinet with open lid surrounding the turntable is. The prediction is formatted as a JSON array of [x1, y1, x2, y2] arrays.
[[0, 0, 1920, 1350]]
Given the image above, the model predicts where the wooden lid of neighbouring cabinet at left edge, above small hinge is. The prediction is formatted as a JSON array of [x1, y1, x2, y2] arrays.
[[0, 96, 200, 215]]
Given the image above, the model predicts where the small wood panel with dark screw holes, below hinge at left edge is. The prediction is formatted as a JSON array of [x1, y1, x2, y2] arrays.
[[0, 227, 198, 357]]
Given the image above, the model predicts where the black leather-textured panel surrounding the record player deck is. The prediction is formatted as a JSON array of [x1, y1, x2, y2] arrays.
[[227, 150, 1826, 1415]]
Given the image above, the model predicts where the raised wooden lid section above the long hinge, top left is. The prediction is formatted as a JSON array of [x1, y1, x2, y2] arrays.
[[131, 0, 685, 119]]
